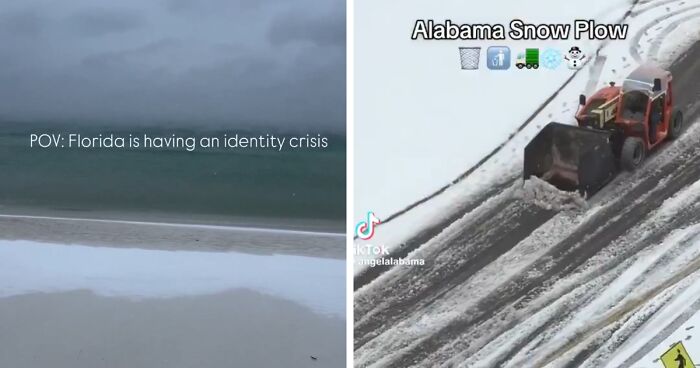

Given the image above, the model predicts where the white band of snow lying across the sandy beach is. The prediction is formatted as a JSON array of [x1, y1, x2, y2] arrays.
[[0, 240, 345, 317]]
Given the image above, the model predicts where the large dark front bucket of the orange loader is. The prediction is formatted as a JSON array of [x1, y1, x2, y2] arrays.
[[523, 123, 617, 196]]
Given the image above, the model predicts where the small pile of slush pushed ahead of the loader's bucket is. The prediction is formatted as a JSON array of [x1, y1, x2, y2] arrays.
[[513, 176, 588, 211]]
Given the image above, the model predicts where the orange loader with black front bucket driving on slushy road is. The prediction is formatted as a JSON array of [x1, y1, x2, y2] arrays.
[[523, 65, 683, 196]]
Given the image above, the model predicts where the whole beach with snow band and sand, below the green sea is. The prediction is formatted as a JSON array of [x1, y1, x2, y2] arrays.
[[0, 215, 345, 367]]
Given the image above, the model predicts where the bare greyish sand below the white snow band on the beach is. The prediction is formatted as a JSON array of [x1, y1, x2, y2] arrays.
[[0, 290, 345, 368]]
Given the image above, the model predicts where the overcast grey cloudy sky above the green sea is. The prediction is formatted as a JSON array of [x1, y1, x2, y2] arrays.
[[0, 0, 345, 131]]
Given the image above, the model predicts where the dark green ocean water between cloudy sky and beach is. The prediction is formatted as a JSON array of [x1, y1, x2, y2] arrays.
[[0, 123, 346, 229]]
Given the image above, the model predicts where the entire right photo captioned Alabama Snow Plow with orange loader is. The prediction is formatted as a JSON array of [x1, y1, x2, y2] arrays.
[[352, 0, 700, 368]]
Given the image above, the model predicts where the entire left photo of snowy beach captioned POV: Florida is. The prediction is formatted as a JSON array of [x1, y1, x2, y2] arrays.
[[0, 0, 347, 368]]
